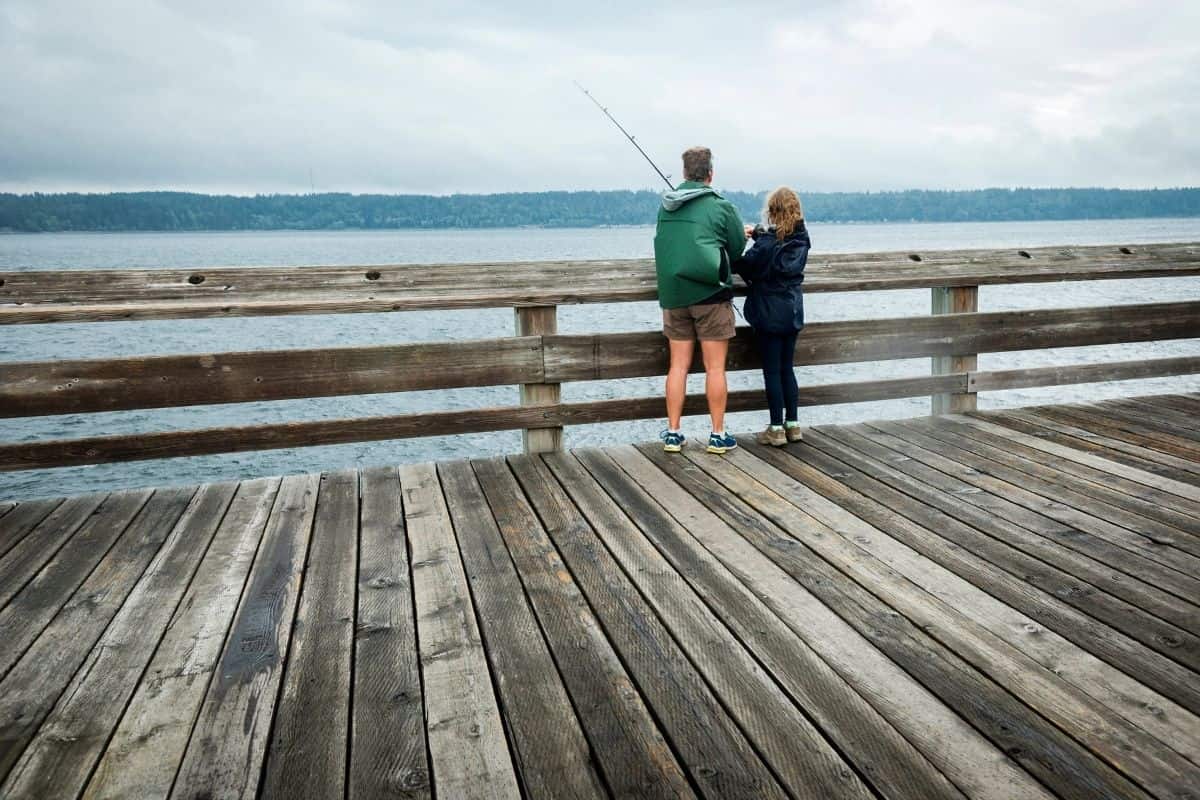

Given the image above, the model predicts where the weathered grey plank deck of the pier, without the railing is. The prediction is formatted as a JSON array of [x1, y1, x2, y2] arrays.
[[0, 395, 1200, 800]]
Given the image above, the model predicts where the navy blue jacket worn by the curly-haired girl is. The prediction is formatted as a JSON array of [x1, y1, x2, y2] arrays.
[[733, 222, 812, 333]]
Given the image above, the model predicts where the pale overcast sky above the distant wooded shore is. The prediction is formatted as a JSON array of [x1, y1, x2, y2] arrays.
[[0, 0, 1200, 194]]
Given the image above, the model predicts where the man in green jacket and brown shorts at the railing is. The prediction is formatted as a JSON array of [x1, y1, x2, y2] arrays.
[[654, 148, 746, 453]]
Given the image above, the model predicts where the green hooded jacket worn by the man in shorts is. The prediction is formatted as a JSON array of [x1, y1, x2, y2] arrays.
[[654, 181, 746, 308]]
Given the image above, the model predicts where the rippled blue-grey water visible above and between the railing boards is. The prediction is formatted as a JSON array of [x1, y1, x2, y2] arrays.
[[0, 218, 1200, 499]]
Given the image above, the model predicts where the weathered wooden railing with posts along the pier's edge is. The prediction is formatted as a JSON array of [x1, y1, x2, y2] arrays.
[[0, 243, 1200, 470]]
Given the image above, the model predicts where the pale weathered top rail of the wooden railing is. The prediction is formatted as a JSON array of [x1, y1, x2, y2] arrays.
[[0, 243, 1200, 324]]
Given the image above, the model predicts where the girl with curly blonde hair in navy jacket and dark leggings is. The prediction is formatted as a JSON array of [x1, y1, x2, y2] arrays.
[[733, 186, 811, 447]]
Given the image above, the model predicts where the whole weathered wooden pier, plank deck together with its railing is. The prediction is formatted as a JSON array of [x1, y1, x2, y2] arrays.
[[0, 245, 1200, 800]]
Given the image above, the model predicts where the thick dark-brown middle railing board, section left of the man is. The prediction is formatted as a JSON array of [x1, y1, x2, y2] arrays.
[[0, 336, 542, 417]]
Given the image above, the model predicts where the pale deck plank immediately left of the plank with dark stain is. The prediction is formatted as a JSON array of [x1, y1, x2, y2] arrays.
[[83, 479, 280, 800]]
